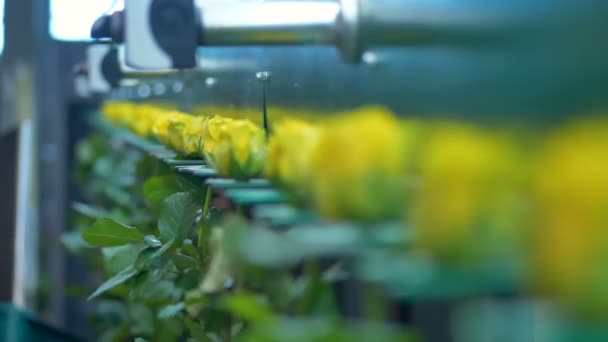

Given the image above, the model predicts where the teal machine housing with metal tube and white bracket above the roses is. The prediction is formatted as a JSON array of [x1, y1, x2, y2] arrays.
[[86, 0, 608, 121]]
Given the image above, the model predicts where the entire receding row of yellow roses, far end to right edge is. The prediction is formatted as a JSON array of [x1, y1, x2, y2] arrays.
[[103, 103, 608, 312]]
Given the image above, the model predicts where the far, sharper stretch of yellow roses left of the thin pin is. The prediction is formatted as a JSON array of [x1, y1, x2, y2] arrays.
[[103, 102, 266, 179]]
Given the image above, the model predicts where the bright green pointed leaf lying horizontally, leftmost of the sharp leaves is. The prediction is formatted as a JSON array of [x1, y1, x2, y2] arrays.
[[82, 217, 144, 247]]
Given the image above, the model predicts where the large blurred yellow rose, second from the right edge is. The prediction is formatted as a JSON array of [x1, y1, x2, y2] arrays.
[[408, 123, 525, 262]]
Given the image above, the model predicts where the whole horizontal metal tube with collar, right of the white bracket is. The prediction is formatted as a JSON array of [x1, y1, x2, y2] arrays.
[[200, 0, 542, 61]]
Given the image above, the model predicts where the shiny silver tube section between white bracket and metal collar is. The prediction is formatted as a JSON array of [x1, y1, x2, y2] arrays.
[[201, 1, 340, 46]]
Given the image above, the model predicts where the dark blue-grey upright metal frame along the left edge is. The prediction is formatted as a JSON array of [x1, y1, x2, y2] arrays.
[[0, 0, 85, 334]]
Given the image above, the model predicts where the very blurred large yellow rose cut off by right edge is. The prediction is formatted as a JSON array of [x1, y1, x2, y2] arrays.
[[532, 119, 608, 316]]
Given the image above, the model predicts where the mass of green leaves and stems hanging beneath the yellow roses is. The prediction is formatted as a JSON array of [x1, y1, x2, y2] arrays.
[[62, 132, 422, 342]]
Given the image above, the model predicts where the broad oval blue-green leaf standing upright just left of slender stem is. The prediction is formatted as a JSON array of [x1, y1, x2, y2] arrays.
[[158, 192, 200, 241]]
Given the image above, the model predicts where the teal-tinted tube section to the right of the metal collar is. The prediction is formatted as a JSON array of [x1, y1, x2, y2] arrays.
[[358, 0, 538, 48]]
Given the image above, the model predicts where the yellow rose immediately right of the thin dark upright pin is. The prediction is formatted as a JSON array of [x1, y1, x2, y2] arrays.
[[264, 119, 321, 201]]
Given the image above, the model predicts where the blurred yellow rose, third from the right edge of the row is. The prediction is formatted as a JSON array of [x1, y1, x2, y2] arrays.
[[312, 107, 409, 221]]
